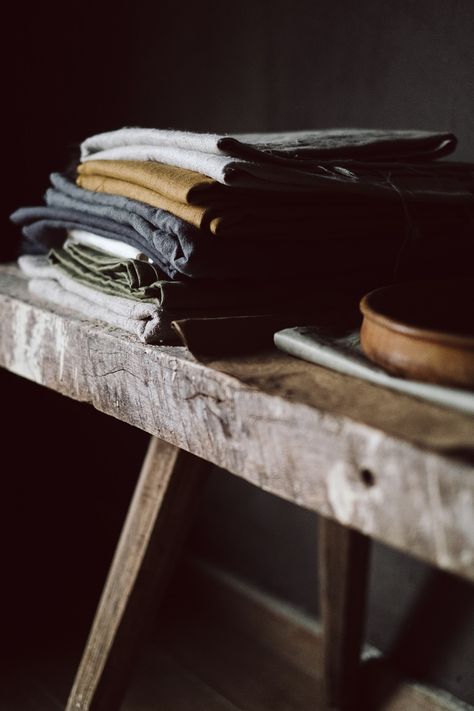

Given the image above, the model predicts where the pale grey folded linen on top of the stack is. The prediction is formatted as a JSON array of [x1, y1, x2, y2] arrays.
[[81, 128, 456, 194]]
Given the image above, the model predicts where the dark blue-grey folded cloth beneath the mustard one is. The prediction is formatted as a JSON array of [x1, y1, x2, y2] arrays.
[[11, 174, 396, 279]]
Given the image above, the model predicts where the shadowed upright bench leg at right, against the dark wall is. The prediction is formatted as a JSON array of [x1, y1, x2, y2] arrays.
[[319, 517, 370, 711]]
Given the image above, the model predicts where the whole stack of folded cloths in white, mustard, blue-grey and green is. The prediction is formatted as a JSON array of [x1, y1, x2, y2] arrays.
[[12, 128, 474, 343]]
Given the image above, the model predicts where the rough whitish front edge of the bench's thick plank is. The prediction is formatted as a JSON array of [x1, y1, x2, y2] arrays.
[[0, 278, 474, 580]]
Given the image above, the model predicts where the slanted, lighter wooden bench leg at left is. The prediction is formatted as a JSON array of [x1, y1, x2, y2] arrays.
[[66, 437, 211, 711]]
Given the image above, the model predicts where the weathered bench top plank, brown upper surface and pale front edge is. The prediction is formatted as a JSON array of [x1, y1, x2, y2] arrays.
[[0, 267, 474, 579]]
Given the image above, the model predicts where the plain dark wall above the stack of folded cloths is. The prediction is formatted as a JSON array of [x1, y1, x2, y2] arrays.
[[2, 0, 474, 258]]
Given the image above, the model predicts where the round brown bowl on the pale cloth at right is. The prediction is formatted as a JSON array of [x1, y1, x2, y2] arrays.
[[360, 279, 474, 388]]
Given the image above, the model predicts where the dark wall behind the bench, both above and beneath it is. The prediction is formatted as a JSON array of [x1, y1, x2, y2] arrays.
[[0, 0, 474, 702]]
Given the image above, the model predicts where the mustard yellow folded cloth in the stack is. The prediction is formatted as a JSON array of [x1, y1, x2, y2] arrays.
[[76, 160, 410, 240]]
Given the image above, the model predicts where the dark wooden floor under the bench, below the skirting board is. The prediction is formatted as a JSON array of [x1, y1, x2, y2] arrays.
[[0, 568, 321, 711]]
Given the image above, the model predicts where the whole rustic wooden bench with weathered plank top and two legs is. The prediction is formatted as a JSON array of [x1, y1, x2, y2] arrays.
[[0, 266, 474, 711]]
